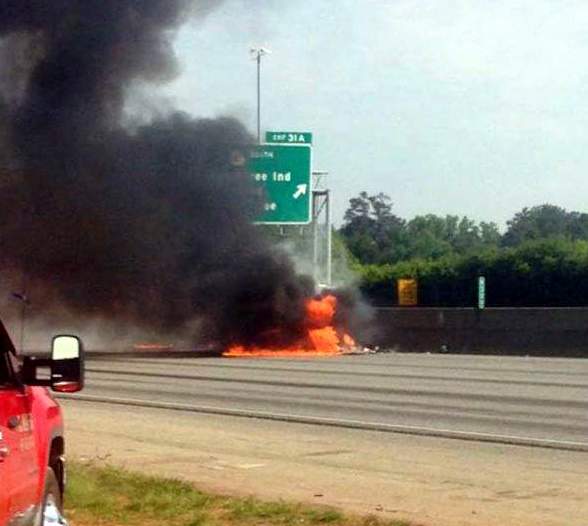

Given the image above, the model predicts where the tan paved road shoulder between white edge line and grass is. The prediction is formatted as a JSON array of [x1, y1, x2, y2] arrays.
[[63, 401, 588, 526]]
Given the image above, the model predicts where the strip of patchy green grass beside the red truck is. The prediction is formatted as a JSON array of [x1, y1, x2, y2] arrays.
[[65, 463, 410, 526]]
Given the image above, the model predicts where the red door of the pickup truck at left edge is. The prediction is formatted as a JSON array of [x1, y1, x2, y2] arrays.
[[0, 386, 39, 526]]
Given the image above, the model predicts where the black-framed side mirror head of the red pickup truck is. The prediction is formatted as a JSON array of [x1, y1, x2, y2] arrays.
[[51, 335, 84, 393]]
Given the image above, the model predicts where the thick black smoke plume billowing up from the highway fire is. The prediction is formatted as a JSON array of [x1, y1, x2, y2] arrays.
[[0, 0, 312, 343]]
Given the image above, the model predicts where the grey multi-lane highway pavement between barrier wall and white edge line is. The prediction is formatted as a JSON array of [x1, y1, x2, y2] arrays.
[[64, 353, 588, 451]]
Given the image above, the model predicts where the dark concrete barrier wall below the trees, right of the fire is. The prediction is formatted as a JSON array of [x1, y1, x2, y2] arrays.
[[364, 307, 588, 358]]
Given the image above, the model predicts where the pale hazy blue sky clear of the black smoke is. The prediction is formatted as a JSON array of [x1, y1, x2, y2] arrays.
[[159, 0, 588, 227]]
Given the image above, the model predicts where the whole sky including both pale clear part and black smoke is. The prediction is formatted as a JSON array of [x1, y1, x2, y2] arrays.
[[0, 0, 588, 343]]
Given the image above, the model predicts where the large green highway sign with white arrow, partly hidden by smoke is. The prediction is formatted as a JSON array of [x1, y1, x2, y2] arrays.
[[247, 144, 312, 225]]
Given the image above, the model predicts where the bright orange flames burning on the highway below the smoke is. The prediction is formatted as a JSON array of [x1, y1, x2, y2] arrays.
[[223, 295, 355, 357]]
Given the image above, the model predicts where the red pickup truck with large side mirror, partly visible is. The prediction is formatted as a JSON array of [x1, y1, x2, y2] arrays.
[[0, 321, 84, 526]]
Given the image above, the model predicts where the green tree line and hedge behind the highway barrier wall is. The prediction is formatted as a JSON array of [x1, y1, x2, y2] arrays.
[[338, 192, 588, 306]]
